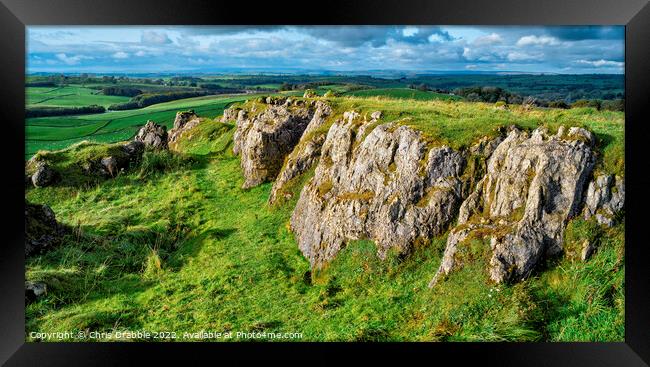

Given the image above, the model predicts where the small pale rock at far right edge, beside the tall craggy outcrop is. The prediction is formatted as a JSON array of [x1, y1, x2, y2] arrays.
[[584, 175, 625, 227]]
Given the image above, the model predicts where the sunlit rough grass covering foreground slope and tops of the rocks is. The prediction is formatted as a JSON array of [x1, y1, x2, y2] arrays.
[[26, 98, 624, 341]]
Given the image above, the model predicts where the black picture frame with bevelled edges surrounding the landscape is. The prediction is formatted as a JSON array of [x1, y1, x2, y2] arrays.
[[0, 0, 650, 366]]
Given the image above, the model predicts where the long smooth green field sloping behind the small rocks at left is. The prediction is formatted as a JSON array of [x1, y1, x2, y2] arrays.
[[25, 96, 250, 159]]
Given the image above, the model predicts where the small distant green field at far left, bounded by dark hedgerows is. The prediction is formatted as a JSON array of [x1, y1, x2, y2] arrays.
[[25, 85, 129, 107]]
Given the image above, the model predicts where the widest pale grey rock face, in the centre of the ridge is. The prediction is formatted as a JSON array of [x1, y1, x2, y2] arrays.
[[291, 112, 465, 268]]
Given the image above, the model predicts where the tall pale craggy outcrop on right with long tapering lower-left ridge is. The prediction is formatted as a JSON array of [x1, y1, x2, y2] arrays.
[[430, 127, 595, 286]]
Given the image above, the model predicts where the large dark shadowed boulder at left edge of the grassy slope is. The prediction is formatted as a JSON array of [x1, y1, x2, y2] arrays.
[[25, 200, 65, 256]]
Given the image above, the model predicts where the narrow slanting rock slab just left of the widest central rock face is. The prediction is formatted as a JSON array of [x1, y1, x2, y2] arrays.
[[269, 101, 332, 204]]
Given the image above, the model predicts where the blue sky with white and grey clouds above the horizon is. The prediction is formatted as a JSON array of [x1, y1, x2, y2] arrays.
[[26, 26, 624, 74]]
